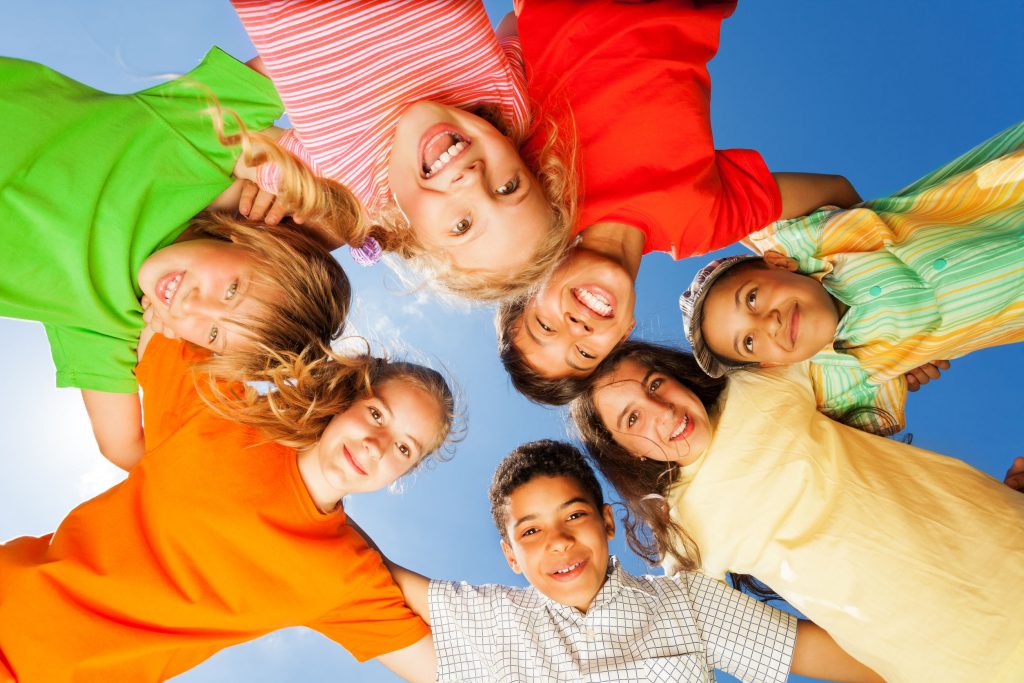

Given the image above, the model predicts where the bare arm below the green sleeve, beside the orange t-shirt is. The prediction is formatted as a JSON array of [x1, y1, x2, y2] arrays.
[[82, 389, 145, 470]]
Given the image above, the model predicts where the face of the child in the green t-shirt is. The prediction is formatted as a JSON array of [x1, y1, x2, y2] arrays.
[[138, 239, 268, 352]]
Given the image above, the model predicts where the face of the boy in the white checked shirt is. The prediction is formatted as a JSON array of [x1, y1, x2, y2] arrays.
[[502, 476, 615, 612]]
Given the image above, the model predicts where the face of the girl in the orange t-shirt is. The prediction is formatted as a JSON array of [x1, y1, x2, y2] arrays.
[[299, 378, 441, 510]]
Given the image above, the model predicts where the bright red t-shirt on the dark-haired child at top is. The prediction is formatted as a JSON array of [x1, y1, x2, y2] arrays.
[[519, 0, 781, 259]]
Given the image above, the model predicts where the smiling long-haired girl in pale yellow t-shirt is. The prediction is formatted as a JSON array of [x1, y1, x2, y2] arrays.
[[571, 342, 1024, 682]]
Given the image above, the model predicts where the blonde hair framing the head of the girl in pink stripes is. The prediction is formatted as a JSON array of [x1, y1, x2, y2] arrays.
[[370, 109, 579, 302]]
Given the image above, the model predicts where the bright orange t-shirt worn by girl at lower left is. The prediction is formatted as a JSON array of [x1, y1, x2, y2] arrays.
[[0, 335, 429, 683]]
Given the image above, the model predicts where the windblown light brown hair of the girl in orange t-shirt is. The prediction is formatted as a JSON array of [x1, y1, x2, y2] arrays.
[[197, 344, 462, 469]]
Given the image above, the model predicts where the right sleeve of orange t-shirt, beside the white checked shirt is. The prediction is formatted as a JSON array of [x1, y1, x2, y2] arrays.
[[309, 524, 430, 661]]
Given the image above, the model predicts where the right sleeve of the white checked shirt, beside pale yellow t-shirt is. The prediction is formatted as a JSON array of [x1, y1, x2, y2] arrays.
[[680, 572, 797, 683]]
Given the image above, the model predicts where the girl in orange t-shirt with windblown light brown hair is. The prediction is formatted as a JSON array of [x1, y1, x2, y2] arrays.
[[0, 329, 454, 683]]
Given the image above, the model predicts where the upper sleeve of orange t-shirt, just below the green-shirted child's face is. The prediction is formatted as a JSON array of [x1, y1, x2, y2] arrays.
[[135, 334, 209, 451]]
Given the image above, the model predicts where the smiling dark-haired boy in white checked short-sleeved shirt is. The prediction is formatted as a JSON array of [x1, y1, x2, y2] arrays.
[[389, 440, 880, 682]]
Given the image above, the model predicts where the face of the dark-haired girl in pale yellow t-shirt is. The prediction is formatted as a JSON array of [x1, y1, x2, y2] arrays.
[[594, 359, 712, 465]]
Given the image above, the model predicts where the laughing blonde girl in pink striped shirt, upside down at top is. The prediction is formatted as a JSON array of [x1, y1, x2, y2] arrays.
[[232, 0, 574, 300]]
